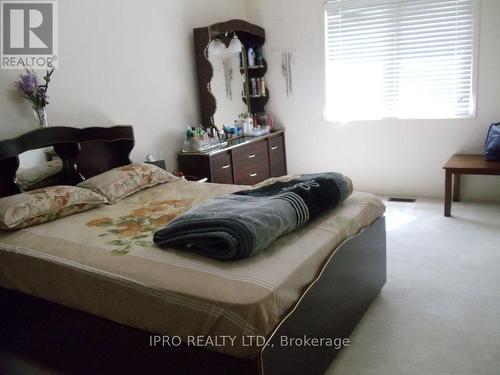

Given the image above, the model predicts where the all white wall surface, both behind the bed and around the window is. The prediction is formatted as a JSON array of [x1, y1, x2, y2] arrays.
[[0, 0, 500, 200]]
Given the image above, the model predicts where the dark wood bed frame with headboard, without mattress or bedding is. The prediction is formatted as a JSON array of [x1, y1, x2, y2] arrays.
[[0, 126, 386, 375]]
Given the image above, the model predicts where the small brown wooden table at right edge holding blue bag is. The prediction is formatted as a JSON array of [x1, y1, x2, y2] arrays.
[[443, 154, 500, 217]]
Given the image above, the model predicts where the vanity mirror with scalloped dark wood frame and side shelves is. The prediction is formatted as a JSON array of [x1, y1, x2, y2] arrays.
[[194, 20, 269, 132]]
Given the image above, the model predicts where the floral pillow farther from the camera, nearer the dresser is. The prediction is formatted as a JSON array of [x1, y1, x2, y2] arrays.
[[78, 163, 179, 204]]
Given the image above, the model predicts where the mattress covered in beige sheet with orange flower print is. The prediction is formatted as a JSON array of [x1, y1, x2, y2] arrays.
[[0, 181, 385, 359]]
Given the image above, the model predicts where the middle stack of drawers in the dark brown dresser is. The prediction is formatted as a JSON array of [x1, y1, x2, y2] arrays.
[[233, 140, 269, 185]]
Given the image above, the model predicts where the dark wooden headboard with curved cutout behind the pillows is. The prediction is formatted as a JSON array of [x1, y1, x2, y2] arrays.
[[0, 126, 134, 197]]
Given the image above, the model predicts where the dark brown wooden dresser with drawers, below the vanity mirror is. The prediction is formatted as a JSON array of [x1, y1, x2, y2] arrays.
[[177, 130, 286, 185]]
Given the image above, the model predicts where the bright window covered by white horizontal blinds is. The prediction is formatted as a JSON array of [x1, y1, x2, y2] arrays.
[[325, 0, 477, 121]]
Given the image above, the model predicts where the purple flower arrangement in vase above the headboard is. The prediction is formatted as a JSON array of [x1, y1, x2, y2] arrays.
[[15, 68, 54, 127]]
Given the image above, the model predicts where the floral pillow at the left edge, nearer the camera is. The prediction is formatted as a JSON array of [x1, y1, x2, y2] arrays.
[[0, 186, 106, 229]]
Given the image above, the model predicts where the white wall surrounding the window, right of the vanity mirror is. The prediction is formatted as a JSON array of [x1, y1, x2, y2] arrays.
[[247, 0, 500, 200]]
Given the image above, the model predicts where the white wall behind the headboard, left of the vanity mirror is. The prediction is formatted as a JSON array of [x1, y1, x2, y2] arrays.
[[0, 0, 246, 169]]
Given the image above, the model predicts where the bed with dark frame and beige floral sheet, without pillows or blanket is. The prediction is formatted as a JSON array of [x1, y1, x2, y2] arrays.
[[0, 126, 386, 374]]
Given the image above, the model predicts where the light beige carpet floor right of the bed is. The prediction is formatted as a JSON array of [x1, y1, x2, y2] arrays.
[[327, 200, 500, 375]]
